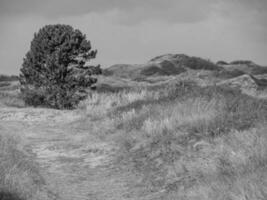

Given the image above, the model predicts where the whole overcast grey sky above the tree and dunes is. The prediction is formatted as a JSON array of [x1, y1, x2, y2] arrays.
[[0, 0, 267, 74]]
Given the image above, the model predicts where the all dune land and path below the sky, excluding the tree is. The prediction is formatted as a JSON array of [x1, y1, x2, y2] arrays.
[[0, 54, 267, 200]]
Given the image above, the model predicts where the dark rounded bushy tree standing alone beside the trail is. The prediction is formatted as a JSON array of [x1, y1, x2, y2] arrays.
[[20, 24, 101, 109]]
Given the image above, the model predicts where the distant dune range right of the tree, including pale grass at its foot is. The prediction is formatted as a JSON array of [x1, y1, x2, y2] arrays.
[[100, 54, 267, 96]]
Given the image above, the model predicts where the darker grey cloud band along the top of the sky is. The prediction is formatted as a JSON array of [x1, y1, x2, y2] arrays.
[[0, 0, 267, 24]]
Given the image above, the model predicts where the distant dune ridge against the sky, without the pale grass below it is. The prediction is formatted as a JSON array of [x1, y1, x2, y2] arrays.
[[103, 54, 267, 81]]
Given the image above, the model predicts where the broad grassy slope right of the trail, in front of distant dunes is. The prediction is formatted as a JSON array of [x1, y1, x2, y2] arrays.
[[80, 82, 267, 200]]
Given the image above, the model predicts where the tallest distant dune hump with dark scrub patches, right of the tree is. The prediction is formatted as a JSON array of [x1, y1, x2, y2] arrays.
[[103, 54, 222, 80]]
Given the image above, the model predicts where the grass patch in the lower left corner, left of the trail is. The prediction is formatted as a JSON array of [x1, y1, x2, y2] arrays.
[[0, 127, 47, 200]]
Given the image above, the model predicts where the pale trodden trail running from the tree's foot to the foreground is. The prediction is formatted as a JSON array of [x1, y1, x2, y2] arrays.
[[0, 108, 146, 200]]
